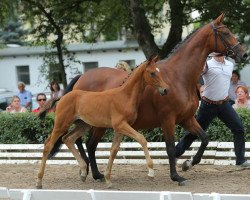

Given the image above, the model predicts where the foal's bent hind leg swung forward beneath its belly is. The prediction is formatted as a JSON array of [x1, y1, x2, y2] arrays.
[[62, 120, 91, 181]]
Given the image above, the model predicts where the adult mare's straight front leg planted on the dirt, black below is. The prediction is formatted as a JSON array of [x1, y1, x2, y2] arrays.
[[162, 118, 187, 186]]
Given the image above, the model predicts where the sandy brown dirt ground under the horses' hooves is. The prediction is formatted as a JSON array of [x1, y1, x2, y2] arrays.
[[0, 164, 250, 194]]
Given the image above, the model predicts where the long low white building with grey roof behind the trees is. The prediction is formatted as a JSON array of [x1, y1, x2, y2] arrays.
[[0, 41, 250, 94]]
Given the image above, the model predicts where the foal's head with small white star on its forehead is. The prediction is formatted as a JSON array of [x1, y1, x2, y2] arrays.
[[143, 56, 169, 96]]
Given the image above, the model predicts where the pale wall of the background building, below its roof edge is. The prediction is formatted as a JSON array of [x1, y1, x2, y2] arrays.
[[0, 46, 145, 94]]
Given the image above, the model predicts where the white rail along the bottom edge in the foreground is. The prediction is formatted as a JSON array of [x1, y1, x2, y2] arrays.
[[0, 188, 250, 200]]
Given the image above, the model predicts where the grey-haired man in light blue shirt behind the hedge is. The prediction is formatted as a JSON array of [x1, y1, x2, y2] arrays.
[[17, 82, 32, 110]]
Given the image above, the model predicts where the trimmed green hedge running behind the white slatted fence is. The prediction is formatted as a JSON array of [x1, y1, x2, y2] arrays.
[[0, 109, 250, 144]]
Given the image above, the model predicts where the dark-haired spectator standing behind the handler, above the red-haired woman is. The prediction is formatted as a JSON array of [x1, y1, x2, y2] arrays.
[[229, 70, 246, 105]]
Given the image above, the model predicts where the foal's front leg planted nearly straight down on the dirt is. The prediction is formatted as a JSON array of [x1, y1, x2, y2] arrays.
[[105, 133, 123, 188]]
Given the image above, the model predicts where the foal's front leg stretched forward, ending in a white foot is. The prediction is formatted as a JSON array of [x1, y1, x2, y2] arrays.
[[113, 122, 154, 177]]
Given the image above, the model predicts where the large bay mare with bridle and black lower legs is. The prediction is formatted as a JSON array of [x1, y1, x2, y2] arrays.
[[40, 14, 247, 185]]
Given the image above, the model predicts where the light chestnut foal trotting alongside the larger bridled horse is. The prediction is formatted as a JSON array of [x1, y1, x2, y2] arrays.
[[37, 57, 168, 188]]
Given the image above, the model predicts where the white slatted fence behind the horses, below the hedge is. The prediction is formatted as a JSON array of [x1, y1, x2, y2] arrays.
[[0, 142, 250, 165]]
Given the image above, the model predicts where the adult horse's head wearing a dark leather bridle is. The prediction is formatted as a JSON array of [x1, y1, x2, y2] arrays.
[[210, 14, 247, 62]]
